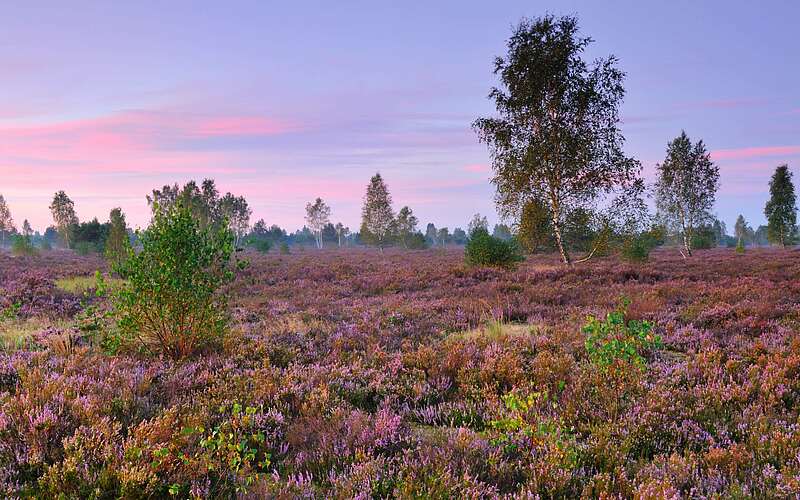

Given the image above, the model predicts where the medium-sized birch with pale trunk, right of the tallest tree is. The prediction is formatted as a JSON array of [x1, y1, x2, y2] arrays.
[[655, 131, 719, 258]]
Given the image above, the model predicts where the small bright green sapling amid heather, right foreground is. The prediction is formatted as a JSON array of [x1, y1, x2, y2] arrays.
[[583, 300, 662, 368]]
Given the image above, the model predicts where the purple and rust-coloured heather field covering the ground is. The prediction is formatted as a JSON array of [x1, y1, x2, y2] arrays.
[[0, 249, 800, 498]]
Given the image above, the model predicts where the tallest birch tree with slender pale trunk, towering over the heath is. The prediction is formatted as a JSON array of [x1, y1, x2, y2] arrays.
[[473, 16, 641, 265]]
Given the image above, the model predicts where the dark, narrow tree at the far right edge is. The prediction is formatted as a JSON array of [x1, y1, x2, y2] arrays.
[[764, 165, 797, 246]]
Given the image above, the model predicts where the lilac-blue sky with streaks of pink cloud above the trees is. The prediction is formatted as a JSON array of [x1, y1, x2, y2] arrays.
[[0, 0, 800, 230]]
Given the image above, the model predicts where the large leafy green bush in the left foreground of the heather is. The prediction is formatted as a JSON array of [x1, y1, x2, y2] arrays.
[[114, 204, 235, 358]]
